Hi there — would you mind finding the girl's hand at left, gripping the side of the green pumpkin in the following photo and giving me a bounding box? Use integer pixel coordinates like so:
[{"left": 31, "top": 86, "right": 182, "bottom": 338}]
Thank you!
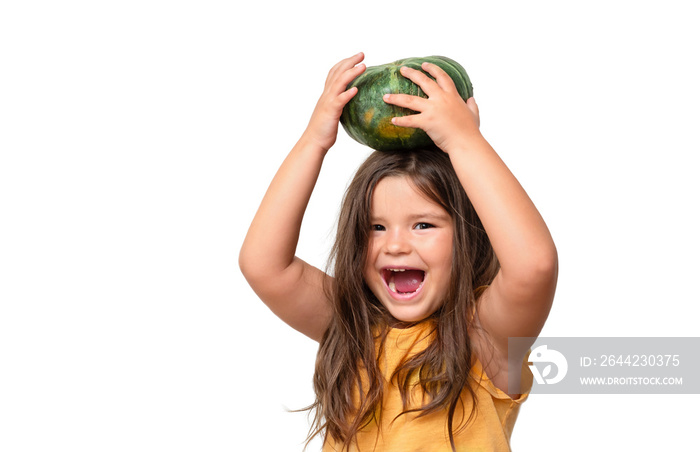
[{"left": 303, "top": 52, "right": 366, "bottom": 152}]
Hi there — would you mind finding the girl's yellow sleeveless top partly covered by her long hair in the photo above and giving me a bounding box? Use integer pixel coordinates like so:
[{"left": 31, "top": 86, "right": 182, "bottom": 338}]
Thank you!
[{"left": 323, "top": 322, "right": 532, "bottom": 452}]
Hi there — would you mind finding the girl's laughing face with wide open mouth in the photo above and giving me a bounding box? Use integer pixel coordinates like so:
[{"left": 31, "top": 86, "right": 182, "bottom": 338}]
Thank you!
[{"left": 363, "top": 176, "right": 454, "bottom": 322}]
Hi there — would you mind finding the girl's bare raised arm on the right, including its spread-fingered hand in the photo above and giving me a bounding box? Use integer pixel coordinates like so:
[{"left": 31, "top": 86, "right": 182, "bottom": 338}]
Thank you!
[{"left": 385, "top": 63, "right": 558, "bottom": 389}]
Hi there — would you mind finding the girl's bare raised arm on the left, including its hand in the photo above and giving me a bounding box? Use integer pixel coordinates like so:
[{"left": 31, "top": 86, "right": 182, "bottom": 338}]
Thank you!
[{"left": 238, "top": 53, "right": 365, "bottom": 340}]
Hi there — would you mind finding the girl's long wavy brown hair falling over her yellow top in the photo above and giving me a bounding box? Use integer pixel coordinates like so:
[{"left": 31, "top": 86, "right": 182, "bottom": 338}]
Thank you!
[{"left": 307, "top": 149, "right": 499, "bottom": 450}]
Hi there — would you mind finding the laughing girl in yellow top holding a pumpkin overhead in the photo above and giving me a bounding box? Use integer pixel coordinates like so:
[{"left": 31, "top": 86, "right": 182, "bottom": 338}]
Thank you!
[{"left": 239, "top": 53, "right": 557, "bottom": 451}]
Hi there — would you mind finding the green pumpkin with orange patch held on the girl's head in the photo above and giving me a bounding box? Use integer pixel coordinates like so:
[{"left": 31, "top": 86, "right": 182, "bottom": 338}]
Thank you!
[{"left": 340, "top": 56, "right": 473, "bottom": 151}]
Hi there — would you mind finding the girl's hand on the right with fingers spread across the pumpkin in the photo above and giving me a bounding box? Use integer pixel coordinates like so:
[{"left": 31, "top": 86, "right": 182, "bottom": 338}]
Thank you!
[{"left": 384, "top": 63, "right": 481, "bottom": 154}]
